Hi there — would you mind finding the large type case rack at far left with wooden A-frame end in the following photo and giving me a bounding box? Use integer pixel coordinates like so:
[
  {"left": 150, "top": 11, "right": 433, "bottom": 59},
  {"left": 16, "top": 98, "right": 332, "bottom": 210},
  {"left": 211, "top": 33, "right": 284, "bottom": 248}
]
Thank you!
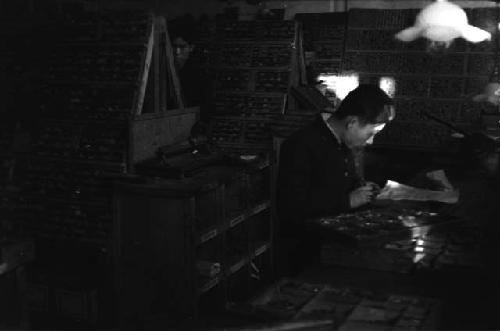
[{"left": 0, "top": 8, "right": 198, "bottom": 327}]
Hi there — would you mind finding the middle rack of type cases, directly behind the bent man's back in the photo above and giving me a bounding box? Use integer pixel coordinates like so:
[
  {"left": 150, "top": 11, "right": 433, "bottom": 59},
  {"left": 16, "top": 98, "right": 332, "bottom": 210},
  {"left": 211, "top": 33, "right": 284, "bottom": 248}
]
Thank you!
[{"left": 211, "top": 21, "right": 305, "bottom": 153}]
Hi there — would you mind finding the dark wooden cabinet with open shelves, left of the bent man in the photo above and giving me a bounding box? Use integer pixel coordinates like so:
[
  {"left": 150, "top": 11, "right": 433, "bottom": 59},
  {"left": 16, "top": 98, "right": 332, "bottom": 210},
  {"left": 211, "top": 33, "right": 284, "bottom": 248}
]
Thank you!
[{"left": 114, "top": 162, "right": 273, "bottom": 325}]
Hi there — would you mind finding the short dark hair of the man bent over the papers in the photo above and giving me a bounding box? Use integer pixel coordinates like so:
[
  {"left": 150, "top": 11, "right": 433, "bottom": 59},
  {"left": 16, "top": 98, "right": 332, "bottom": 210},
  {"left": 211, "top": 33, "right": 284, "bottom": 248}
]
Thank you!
[{"left": 333, "top": 84, "right": 394, "bottom": 124}]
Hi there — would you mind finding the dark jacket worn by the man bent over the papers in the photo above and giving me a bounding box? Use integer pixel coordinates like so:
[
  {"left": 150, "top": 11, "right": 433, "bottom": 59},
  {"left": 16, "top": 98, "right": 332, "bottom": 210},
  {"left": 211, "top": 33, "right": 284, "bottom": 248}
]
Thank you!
[{"left": 277, "top": 116, "right": 360, "bottom": 236}]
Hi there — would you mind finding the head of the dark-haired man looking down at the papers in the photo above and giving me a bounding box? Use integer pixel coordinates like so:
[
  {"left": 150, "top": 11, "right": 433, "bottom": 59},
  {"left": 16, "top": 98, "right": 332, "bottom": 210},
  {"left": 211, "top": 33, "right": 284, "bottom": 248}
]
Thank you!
[{"left": 332, "top": 84, "right": 395, "bottom": 148}]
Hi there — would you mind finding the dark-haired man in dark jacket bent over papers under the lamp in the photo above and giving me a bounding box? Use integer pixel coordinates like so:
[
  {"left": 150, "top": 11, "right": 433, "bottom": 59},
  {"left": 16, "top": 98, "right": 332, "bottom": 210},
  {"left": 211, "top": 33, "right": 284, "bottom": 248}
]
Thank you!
[{"left": 277, "top": 85, "right": 394, "bottom": 274}]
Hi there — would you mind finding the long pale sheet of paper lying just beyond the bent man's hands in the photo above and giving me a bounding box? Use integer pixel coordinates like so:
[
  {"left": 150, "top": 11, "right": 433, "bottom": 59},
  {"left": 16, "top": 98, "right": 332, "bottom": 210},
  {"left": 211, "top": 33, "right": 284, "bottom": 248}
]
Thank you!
[{"left": 377, "top": 180, "right": 459, "bottom": 203}]
